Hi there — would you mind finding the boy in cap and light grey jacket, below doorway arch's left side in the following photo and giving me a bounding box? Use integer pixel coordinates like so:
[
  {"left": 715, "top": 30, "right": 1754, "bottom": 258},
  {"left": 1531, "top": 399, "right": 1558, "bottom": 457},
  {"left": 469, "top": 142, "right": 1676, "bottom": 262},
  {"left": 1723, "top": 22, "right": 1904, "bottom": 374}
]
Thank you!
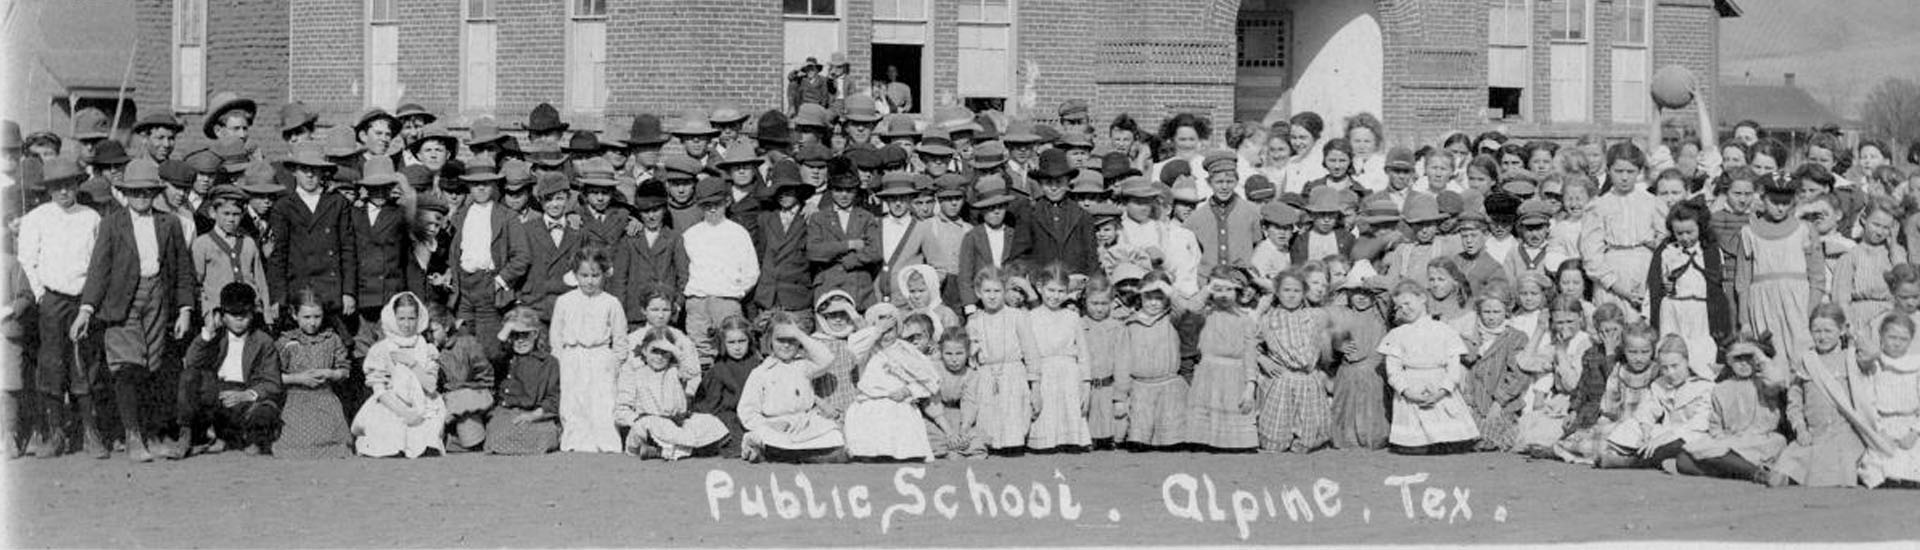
[{"left": 1187, "top": 150, "right": 1260, "bottom": 273}]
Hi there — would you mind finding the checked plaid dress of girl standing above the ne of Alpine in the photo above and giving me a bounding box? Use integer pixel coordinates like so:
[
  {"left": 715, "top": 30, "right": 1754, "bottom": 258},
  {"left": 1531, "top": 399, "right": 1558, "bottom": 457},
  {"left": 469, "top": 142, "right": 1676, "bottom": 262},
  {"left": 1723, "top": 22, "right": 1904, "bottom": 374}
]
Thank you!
[{"left": 1260, "top": 308, "right": 1332, "bottom": 452}]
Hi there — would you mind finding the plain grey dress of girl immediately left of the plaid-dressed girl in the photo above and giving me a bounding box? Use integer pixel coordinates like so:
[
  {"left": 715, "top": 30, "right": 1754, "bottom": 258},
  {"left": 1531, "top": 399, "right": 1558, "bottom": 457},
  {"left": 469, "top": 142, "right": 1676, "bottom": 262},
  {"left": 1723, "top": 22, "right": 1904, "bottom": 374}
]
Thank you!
[{"left": 1187, "top": 312, "right": 1260, "bottom": 448}]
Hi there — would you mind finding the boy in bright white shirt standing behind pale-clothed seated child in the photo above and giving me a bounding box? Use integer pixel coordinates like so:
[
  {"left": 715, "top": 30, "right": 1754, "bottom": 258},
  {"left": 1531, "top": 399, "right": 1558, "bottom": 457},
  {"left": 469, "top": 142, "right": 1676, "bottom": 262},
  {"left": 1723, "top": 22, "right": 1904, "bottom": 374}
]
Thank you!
[{"left": 682, "top": 177, "right": 760, "bottom": 363}]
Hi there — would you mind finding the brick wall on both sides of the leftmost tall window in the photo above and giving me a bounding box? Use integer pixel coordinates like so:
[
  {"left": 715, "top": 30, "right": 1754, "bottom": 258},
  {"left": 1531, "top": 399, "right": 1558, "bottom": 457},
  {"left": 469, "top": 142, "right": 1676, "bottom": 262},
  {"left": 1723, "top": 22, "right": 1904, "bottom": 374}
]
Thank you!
[{"left": 132, "top": 0, "right": 298, "bottom": 158}]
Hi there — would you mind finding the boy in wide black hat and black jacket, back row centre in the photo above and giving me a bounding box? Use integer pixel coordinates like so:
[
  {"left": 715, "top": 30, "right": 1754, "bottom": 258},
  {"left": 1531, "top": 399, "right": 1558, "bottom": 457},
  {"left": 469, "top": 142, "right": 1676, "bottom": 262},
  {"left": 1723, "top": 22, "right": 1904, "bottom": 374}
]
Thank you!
[{"left": 1014, "top": 150, "right": 1098, "bottom": 275}]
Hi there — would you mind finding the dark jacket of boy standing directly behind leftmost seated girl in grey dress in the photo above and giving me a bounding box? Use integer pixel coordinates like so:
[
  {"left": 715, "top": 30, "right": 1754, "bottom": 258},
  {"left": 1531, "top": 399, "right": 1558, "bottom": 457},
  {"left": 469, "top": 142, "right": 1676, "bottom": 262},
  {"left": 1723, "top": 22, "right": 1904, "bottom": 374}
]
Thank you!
[{"left": 267, "top": 190, "right": 359, "bottom": 304}]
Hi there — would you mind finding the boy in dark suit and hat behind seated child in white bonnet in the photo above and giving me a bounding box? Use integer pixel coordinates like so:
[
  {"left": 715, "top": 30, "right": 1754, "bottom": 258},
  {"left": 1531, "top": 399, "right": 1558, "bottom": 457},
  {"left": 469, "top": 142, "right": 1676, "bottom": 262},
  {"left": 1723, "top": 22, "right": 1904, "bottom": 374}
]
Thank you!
[{"left": 349, "top": 158, "right": 424, "bottom": 354}]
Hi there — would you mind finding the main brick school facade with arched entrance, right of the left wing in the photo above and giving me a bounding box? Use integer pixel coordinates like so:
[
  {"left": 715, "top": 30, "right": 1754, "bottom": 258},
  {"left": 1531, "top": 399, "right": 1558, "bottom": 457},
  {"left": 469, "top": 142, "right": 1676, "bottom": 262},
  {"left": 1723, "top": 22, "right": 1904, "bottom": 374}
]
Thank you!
[{"left": 266, "top": 0, "right": 1738, "bottom": 142}]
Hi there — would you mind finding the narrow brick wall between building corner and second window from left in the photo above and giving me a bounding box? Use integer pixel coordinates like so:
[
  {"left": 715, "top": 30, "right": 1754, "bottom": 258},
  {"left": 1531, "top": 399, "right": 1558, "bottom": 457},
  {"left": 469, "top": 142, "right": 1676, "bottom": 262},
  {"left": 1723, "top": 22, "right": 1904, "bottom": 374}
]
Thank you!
[{"left": 286, "top": 0, "right": 367, "bottom": 125}]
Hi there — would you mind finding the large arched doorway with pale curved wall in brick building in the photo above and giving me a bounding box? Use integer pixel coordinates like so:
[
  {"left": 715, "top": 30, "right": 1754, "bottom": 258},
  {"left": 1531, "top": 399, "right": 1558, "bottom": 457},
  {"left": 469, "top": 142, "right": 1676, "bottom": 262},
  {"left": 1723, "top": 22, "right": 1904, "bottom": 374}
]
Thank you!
[{"left": 1233, "top": 0, "right": 1386, "bottom": 129}]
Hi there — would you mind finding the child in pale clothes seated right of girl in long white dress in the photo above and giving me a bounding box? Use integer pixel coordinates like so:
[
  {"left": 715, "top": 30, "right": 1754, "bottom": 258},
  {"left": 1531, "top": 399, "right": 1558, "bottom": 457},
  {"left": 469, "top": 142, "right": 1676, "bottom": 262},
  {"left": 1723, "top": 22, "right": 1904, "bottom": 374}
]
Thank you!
[{"left": 612, "top": 327, "right": 728, "bottom": 460}]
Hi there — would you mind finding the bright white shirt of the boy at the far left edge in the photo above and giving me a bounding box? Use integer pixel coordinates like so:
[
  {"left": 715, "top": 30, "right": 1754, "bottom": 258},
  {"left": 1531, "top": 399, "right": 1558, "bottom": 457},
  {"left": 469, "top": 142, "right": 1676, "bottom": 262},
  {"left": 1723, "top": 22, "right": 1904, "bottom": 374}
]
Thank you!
[{"left": 19, "top": 202, "right": 100, "bottom": 298}]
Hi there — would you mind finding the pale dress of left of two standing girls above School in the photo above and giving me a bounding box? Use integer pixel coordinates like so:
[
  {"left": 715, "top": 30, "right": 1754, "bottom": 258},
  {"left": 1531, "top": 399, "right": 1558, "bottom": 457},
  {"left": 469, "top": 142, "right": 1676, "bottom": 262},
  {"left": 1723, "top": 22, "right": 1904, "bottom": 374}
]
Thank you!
[{"left": 966, "top": 308, "right": 1033, "bottom": 448}]
